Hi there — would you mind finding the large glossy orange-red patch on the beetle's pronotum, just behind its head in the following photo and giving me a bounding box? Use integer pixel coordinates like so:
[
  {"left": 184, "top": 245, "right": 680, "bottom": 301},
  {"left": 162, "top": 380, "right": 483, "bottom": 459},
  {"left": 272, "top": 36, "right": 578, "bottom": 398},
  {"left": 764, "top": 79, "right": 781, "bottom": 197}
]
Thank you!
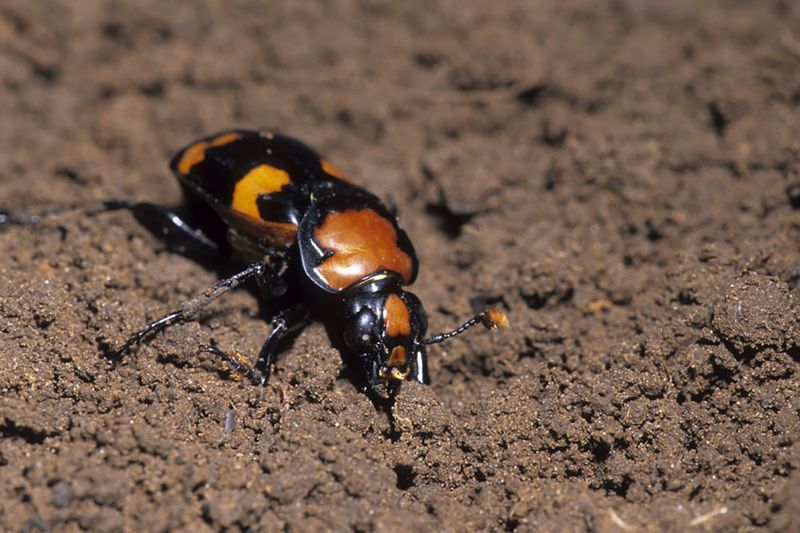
[{"left": 314, "top": 208, "right": 413, "bottom": 289}]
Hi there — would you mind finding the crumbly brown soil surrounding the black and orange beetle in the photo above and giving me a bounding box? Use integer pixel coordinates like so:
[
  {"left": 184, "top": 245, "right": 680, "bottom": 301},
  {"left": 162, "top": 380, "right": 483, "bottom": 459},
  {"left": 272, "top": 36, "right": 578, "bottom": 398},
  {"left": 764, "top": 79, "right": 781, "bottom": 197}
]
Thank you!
[{"left": 0, "top": 0, "right": 800, "bottom": 532}]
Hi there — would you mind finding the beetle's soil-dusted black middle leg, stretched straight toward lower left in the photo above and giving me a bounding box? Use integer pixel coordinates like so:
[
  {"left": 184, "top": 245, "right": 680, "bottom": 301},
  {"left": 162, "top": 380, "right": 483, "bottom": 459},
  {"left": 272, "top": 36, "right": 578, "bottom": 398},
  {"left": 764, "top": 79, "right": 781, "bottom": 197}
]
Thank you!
[{"left": 111, "top": 262, "right": 268, "bottom": 359}]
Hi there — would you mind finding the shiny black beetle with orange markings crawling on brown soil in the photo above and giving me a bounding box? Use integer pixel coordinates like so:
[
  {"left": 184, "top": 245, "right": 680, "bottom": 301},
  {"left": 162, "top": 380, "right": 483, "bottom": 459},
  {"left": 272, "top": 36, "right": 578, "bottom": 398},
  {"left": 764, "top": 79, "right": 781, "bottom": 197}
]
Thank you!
[{"left": 0, "top": 129, "right": 508, "bottom": 398}]
